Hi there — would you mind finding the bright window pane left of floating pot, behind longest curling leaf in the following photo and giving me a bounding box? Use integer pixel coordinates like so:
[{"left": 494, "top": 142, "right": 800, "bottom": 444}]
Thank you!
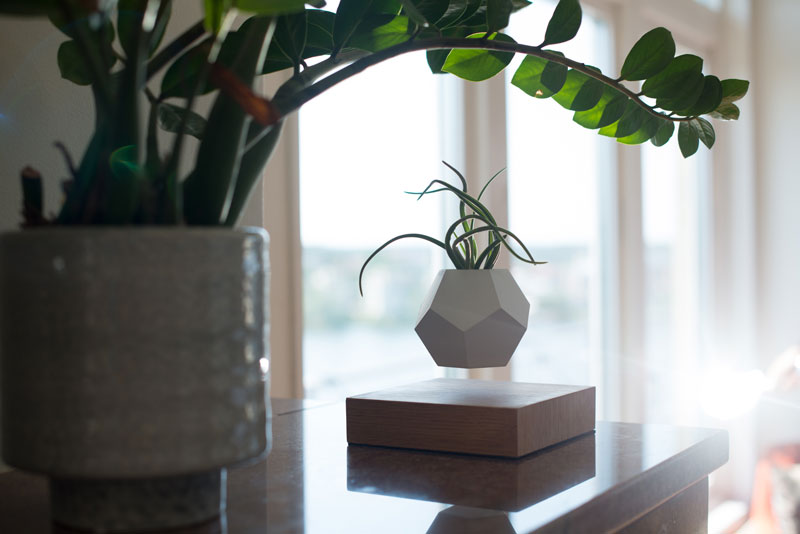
[{"left": 300, "top": 54, "right": 441, "bottom": 398}]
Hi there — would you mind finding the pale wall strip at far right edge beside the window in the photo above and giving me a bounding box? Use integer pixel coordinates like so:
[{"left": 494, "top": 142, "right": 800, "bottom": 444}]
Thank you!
[{"left": 749, "top": 0, "right": 800, "bottom": 366}]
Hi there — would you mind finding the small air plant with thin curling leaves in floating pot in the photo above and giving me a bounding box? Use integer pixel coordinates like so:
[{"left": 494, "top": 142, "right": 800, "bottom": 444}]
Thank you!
[{"left": 358, "top": 161, "right": 547, "bottom": 296}]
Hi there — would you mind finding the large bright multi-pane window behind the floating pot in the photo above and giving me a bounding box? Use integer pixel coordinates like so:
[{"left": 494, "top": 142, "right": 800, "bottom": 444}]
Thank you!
[{"left": 273, "top": 0, "right": 746, "bottom": 478}]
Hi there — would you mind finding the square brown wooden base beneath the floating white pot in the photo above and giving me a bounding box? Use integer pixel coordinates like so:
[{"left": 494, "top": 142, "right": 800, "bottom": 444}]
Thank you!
[{"left": 347, "top": 378, "right": 595, "bottom": 458}]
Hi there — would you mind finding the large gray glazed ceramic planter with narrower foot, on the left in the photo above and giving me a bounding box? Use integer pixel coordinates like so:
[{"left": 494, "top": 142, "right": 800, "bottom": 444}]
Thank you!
[{"left": 0, "top": 228, "right": 268, "bottom": 531}]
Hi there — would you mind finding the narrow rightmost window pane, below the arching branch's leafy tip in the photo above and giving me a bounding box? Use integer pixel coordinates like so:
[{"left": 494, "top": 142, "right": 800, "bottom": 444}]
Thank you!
[{"left": 642, "top": 141, "right": 709, "bottom": 424}]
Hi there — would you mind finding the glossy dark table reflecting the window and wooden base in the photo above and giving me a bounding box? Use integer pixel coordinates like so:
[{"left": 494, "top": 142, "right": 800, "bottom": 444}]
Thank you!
[{"left": 0, "top": 400, "right": 728, "bottom": 534}]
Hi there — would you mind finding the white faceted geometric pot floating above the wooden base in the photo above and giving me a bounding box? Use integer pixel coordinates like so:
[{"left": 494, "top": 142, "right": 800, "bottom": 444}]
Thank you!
[{"left": 415, "top": 269, "right": 530, "bottom": 369}]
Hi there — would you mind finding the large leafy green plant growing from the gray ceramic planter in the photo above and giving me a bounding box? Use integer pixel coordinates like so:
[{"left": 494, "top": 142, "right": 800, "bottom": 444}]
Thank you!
[{"left": 0, "top": 0, "right": 748, "bottom": 228}]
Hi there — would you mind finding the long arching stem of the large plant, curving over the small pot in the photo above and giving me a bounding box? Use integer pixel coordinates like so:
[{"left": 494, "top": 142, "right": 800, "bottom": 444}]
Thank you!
[{"left": 273, "top": 37, "right": 694, "bottom": 122}]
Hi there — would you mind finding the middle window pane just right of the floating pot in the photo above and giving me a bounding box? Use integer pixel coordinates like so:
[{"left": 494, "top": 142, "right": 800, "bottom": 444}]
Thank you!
[{"left": 507, "top": 1, "right": 610, "bottom": 390}]
